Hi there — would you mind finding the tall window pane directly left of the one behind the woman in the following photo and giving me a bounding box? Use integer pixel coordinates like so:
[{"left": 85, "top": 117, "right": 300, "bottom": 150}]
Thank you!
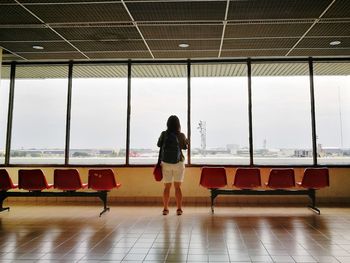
[{"left": 69, "top": 65, "right": 127, "bottom": 164}]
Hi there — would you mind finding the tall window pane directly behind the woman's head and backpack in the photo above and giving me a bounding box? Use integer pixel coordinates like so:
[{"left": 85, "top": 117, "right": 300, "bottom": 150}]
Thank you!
[{"left": 130, "top": 65, "right": 187, "bottom": 164}]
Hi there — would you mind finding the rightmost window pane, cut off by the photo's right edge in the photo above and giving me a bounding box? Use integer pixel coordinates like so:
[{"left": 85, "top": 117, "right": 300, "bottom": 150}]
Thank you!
[{"left": 314, "top": 63, "right": 350, "bottom": 164}]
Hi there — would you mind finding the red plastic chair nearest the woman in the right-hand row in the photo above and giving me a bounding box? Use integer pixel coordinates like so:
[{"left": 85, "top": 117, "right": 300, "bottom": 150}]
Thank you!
[{"left": 199, "top": 167, "right": 227, "bottom": 189}]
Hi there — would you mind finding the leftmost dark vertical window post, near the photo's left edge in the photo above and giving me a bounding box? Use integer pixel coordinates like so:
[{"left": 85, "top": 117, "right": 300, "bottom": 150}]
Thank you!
[{"left": 5, "top": 62, "right": 16, "bottom": 166}]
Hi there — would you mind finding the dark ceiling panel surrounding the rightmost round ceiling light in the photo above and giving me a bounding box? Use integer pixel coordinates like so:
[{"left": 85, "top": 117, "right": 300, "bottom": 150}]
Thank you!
[{"left": 296, "top": 36, "right": 350, "bottom": 49}]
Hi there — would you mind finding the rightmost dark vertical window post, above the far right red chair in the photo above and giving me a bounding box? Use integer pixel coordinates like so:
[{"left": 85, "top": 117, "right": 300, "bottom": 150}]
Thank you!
[{"left": 309, "top": 57, "right": 317, "bottom": 166}]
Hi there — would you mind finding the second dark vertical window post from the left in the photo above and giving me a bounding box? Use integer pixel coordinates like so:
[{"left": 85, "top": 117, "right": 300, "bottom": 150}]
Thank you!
[{"left": 64, "top": 62, "right": 73, "bottom": 165}]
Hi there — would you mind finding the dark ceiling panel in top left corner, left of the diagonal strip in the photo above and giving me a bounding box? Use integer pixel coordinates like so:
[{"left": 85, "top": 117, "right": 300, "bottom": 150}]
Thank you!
[{"left": 0, "top": 5, "right": 41, "bottom": 25}]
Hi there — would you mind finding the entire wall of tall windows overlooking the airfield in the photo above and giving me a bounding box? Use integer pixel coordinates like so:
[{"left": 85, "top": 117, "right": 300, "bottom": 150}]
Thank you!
[{"left": 0, "top": 60, "right": 350, "bottom": 166}]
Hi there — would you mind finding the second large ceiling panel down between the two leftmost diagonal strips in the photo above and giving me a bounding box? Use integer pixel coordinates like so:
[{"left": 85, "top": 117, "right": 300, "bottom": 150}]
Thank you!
[{"left": 54, "top": 26, "right": 141, "bottom": 40}]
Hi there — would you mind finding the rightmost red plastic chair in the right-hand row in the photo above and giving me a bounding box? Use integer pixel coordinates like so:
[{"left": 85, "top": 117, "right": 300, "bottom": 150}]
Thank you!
[{"left": 297, "top": 168, "right": 329, "bottom": 189}]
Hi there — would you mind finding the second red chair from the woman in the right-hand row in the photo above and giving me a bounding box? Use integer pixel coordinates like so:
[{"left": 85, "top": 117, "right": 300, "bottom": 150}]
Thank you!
[{"left": 233, "top": 168, "right": 261, "bottom": 189}]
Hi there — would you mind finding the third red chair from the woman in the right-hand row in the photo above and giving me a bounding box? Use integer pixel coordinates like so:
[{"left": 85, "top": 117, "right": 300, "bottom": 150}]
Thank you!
[{"left": 266, "top": 169, "right": 295, "bottom": 189}]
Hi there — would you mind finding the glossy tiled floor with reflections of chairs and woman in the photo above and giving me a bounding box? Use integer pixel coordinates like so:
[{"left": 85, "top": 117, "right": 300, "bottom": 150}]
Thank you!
[{"left": 0, "top": 205, "right": 350, "bottom": 263}]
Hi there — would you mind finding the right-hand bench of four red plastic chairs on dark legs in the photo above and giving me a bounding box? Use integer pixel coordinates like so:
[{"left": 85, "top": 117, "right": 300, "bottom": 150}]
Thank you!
[{"left": 200, "top": 167, "right": 329, "bottom": 214}]
